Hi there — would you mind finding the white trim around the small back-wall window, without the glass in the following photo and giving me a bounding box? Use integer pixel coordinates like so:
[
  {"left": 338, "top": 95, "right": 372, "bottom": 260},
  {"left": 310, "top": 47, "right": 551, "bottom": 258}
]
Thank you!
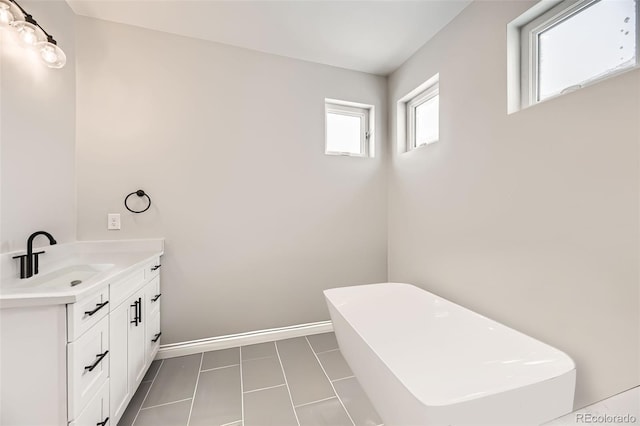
[{"left": 324, "top": 99, "right": 374, "bottom": 157}]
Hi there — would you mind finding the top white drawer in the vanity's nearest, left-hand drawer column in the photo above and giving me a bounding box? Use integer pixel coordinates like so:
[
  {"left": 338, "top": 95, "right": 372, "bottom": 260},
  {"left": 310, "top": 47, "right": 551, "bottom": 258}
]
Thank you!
[{"left": 67, "top": 287, "right": 109, "bottom": 342}]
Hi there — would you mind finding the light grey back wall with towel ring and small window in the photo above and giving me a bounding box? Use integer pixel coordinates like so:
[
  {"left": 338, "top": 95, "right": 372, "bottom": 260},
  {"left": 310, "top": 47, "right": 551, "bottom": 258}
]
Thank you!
[{"left": 77, "top": 17, "right": 387, "bottom": 343}]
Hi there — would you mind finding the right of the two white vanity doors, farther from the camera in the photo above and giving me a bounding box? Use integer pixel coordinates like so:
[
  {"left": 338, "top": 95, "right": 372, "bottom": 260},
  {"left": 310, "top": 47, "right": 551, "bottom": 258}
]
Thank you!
[{"left": 127, "top": 288, "right": 147, "bottom": 390}]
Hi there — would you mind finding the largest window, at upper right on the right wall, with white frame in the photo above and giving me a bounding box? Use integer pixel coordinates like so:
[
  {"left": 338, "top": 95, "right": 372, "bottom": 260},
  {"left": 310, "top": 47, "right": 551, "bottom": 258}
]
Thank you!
[{"left": 520, "top": 0, "right": 640, "bottom": 107}]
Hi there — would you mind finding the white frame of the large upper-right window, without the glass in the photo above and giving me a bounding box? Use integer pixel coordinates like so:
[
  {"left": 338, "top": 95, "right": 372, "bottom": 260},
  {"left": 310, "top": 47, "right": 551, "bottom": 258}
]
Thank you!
[{"left": 519, "top": 0, "right": 640, "bottom": 108}]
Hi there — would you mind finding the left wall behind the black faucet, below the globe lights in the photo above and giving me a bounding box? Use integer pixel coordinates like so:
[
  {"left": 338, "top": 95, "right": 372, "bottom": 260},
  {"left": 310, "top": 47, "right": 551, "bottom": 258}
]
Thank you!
[{"left": 0, "top": 1, "right": 76, "bottom": 253}]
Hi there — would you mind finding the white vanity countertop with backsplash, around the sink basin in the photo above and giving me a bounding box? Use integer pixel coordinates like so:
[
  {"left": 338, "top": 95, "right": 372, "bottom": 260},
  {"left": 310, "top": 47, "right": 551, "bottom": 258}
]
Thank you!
[{"left": 0, "top": 239, "right": 164, "bottom": 308}]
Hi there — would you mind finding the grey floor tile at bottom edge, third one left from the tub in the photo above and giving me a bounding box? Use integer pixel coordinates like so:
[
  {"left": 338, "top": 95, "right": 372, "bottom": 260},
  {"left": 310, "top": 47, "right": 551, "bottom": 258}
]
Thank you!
[{"left": 244, "top": 386, "right": 298, "bottom": 426}]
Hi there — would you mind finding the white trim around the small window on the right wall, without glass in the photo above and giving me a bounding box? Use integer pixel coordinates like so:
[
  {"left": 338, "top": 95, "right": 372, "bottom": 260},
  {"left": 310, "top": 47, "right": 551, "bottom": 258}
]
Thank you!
[{"left": 396, "top": 73, "right": 440, "bottom": 153}]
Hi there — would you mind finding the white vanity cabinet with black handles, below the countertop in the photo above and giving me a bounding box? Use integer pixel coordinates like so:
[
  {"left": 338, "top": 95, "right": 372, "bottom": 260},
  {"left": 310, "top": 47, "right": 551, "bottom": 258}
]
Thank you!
[{"left": 0, "top": 250, "right": 160, "bottom": 426}]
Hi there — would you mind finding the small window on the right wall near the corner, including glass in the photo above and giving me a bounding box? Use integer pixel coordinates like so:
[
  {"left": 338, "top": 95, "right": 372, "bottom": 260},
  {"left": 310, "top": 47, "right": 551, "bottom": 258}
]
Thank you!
[{"left": 397, "top": 74, "right": 440, "bottom": 152}]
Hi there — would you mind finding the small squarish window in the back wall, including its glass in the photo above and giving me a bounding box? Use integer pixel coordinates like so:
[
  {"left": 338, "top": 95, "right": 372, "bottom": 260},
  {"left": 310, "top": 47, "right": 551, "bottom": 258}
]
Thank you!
[{"left": 325, "top": 99, "right": 373, "bottom": 157}]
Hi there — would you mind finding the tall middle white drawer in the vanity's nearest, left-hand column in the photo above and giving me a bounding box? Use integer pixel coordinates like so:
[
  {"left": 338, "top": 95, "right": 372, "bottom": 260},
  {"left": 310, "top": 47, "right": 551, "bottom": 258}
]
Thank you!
[{"left": 67, "top": 317, "right": 109, "bottom": 420}]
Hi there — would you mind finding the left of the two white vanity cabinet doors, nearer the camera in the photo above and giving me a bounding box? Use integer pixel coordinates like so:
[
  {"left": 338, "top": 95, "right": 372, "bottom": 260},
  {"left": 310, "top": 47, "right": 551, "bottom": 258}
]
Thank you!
[{"left": 109, "top": 301, "right": 135, "bottom": 421}]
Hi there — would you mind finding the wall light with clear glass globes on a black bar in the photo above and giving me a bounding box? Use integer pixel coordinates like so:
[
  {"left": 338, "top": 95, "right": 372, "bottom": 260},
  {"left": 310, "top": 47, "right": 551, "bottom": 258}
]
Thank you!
[{"left": 0, "top": 0, "right": 67, "bottom": 68}]
